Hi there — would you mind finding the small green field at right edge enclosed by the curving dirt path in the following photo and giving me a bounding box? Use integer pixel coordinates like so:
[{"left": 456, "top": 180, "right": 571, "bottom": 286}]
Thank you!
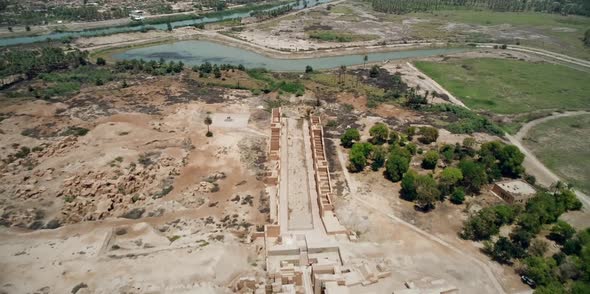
[{"left": 525, "top": 114, "right": 590, "bottom": 193}]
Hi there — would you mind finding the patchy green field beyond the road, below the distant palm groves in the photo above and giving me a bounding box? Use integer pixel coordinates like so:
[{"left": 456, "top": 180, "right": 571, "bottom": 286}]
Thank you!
[{"left": 381, "top": 9, "right": 590, "bottom": 60}]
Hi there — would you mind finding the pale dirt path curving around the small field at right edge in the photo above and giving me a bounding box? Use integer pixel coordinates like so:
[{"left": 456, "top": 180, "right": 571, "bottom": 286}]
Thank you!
[{"left": 506, "top": 111, "right": 590, "bottom": 209}]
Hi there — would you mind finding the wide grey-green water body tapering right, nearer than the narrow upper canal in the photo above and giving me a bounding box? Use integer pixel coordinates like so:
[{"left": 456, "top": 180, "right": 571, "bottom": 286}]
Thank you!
[{"left": 113, "top": 40, "right": 470, "bottom": 71}]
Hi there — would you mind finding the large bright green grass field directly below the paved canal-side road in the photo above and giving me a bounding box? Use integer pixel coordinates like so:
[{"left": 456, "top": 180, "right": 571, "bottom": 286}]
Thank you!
[{"left": 415, "top": 58, "right": 590, "bottom": 115}]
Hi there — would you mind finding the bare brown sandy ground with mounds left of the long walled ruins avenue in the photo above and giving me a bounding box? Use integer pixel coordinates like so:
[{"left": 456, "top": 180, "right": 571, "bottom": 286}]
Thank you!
[{"left": 0, "top": 72, "right": 269, "bottom": 293}]
